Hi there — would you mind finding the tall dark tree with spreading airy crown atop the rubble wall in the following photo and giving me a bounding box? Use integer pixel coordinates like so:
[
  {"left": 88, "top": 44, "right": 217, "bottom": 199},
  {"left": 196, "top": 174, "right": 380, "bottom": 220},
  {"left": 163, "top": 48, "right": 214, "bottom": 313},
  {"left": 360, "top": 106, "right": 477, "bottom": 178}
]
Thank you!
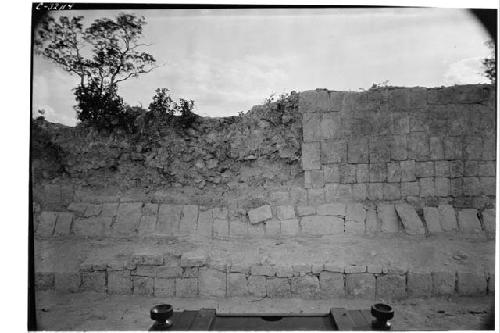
[{"left": 35, "top": 14, "right": 157, "bottom": 127}]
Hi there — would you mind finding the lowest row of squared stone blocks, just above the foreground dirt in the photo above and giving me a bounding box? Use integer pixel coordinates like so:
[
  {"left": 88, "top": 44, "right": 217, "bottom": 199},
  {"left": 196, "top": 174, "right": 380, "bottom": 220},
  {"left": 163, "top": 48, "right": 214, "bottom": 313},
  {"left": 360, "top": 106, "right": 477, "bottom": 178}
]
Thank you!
[{"left": 35, "top": 251, "right": 495, "bottom": 299}]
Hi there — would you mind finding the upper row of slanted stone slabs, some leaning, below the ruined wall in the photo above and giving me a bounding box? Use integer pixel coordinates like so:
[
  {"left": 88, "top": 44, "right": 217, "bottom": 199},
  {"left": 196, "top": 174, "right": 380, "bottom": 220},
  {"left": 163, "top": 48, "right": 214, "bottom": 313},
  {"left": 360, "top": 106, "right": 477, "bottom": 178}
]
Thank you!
[{"left": 35, "top": 196, "right": 495, "bottom": 239}]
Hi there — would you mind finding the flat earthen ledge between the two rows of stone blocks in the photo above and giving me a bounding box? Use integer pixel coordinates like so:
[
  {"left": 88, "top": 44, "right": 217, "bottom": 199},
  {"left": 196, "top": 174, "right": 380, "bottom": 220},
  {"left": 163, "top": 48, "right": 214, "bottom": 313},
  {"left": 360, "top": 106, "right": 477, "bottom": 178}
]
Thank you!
[{"left": 35, "top": 234, "right": 495, "bottom": 272}]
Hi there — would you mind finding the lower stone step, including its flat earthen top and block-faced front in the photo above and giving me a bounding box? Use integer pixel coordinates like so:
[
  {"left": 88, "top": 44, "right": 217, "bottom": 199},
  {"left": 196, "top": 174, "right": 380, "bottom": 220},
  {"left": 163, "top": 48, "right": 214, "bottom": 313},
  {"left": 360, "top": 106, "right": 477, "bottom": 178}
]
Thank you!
[{"left": 35, "top": 235, "right": 495, "bottom": 299}]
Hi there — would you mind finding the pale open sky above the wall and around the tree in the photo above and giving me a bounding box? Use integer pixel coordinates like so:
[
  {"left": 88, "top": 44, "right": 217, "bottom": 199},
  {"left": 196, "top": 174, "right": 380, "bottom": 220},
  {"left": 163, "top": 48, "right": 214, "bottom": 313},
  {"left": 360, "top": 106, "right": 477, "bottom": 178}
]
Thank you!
[{"left": 33, "top": 8, "right": 490, "bottom": 126}]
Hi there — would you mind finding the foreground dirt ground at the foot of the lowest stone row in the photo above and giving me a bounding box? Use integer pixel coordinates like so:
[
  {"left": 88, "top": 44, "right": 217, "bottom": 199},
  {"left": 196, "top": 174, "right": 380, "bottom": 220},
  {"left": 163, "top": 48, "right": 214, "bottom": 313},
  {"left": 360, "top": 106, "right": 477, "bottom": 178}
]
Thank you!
[{"left": 36, "top": 291, "right": 494, "bottom": 331}]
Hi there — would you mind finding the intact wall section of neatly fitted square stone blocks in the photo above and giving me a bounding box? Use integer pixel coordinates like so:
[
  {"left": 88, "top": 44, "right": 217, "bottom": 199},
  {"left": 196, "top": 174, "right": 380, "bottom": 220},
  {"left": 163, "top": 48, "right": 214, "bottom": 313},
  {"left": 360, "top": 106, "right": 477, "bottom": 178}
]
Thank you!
[{"left": 299, "top": 85, "right": 496, "bottom": 209}]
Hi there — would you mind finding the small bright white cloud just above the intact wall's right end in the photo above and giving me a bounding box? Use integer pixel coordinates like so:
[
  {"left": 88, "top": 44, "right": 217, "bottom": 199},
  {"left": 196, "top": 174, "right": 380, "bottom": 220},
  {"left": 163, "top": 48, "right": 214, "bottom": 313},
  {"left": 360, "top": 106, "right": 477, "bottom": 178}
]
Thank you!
[{"left": 444, "top": 57, "right": 488, "bottom": 85}]
